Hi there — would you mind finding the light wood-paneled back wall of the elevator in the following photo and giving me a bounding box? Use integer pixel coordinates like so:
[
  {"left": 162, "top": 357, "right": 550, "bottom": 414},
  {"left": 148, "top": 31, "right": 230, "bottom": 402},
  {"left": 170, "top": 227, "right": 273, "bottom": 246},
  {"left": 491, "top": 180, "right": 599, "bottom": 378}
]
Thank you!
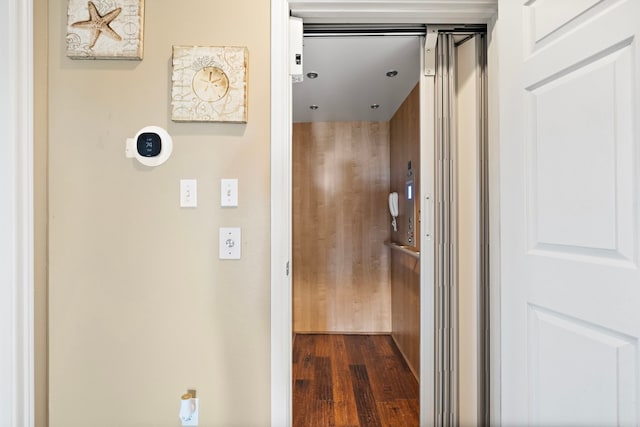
[{"left": 292, "top": 122, "right": 391, "bottom": 332}]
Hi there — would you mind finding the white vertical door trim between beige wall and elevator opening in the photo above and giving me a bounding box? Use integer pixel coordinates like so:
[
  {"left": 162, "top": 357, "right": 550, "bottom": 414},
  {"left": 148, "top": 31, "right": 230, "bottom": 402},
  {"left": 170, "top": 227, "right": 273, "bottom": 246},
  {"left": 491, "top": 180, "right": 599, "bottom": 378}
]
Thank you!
[{"left": 271, "top": 0, "right": 292, "bottom": 427}]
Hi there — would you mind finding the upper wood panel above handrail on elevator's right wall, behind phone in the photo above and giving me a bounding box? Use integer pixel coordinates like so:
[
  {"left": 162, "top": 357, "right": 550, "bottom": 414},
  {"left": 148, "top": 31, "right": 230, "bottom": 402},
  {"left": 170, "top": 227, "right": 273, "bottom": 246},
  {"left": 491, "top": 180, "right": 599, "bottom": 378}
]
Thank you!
[{"left": 389, "top": 85, "right": 420, "bottom": 247}]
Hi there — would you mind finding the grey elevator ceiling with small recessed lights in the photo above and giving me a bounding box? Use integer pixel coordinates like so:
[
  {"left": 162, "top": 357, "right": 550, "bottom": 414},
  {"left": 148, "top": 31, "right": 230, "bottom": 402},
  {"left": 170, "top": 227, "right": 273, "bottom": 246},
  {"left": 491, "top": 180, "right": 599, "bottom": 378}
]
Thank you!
[{"left": 293, "top": 36, "right": 420, "bottom": 122}]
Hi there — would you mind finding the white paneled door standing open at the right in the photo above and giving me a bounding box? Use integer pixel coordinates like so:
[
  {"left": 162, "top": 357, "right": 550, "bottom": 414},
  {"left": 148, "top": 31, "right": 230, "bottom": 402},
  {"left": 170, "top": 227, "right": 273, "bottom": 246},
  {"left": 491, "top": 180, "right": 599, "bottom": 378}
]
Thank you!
[{"left": 499, "top": 0, "right": 640, "bottom": 426}]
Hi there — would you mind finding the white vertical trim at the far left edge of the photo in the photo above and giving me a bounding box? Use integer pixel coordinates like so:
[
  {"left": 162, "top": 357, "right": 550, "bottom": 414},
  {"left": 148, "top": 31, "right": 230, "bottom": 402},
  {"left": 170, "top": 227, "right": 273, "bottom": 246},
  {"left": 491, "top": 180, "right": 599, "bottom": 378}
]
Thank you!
[{"left": 0, "top": 0, "right": 34, "bottom": 427}]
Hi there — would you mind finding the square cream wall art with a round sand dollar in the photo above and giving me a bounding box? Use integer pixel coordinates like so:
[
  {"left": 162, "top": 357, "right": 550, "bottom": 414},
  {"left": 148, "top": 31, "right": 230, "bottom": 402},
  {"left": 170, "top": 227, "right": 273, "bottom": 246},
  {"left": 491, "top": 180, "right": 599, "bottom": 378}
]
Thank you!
[{"left": 171, "top": 46, "right": 248, "bottom": 123}]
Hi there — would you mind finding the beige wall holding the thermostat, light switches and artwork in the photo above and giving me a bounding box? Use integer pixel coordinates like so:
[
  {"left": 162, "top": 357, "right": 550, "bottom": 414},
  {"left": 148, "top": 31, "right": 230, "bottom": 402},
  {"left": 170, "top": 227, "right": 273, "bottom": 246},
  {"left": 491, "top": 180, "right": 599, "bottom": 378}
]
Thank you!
[{"left": 48, "top": 0, "right": 270, "bottom": 427}]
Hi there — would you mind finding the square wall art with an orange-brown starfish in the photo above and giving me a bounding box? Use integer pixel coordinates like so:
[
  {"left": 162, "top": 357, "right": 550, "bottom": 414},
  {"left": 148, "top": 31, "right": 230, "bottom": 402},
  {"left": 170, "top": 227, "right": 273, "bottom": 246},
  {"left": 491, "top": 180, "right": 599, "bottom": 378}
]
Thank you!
[{"left": 67, "top": 0, "right": 144, "bottom": 59}]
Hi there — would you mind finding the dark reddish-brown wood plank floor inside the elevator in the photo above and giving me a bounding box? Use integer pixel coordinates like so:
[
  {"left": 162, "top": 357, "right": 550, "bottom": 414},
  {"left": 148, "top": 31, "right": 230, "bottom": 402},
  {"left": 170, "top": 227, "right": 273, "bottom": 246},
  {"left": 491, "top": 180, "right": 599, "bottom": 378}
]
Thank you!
[{"left": 293, "top": 335, "right": 420, "bottom": 427}]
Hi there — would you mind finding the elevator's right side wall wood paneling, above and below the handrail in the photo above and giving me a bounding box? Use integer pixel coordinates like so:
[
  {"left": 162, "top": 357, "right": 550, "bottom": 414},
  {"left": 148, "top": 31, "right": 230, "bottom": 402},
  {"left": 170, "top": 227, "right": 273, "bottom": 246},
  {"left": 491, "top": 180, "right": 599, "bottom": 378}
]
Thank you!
[{"left": 390, "top": 86, "right": 420, "bottom": 377}]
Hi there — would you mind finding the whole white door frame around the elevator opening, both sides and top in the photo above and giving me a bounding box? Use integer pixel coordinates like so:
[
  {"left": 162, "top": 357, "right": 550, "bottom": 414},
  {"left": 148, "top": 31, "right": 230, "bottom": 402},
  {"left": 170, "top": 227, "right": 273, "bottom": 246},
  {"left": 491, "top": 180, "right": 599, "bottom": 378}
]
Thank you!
[{"left": 270, "top": 0, "right": 500, "bottom": 426}]
